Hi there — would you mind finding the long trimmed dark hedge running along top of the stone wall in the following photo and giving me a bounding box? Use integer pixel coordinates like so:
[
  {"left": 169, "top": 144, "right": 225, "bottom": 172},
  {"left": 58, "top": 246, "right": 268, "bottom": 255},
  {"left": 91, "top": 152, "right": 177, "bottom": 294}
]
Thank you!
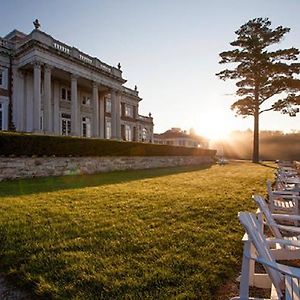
[{"left": 0, "top": 132, "right": 216, "bottom": 157}]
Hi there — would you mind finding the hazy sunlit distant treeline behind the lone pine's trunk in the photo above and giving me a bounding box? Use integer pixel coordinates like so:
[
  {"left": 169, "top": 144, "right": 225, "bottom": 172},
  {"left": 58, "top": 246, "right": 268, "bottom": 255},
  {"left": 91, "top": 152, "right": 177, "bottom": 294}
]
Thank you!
[{"left": 210, "top": 130, "right": 300, "bottom": 160}]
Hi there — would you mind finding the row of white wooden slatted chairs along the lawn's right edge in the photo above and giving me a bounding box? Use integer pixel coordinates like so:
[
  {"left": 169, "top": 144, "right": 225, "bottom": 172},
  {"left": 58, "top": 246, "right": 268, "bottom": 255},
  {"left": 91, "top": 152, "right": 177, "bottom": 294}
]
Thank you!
[{"left": 232, "top": 162, "right": 300, "bottom": 300}]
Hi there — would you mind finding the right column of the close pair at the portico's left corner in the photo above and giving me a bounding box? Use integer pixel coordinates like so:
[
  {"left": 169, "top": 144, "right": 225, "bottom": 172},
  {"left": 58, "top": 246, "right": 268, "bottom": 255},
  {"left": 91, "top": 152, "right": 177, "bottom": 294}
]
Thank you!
[{"left": 44, "top": 65, "right": 52, "bottom": 133}]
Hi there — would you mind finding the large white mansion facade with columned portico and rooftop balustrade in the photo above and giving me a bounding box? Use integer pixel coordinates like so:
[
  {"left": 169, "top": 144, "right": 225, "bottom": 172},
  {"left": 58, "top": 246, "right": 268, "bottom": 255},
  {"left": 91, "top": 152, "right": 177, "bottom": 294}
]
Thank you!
[{"left": 0, "top": 24, "right": 153, "bottom": 142}]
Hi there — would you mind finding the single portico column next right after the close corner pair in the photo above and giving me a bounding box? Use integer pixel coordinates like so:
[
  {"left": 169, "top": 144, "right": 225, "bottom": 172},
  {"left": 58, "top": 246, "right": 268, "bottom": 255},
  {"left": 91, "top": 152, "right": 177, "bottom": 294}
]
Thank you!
[{"left": 71, "top": 75, "right": 80, "bottom": 136}]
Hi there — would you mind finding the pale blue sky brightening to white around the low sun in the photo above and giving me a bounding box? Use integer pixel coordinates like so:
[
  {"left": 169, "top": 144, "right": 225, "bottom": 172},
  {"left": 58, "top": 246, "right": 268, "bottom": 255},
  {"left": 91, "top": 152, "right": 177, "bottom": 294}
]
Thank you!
[{"left": 0, "top": 0, "right": 300, "bottom": 138}]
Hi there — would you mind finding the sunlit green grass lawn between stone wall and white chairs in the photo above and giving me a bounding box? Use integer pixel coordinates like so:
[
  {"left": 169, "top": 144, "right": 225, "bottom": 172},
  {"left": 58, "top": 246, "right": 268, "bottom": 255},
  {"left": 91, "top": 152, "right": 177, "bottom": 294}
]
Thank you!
[{"left": 0, "top": 162, "right": 273, "bottom": 299}]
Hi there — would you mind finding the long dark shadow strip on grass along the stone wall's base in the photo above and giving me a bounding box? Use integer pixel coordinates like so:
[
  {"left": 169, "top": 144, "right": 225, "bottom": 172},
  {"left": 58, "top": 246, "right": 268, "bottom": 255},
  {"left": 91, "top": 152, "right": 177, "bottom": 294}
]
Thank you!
[{"left": 0, "top": 164, "right": 211, "bottom": 197}]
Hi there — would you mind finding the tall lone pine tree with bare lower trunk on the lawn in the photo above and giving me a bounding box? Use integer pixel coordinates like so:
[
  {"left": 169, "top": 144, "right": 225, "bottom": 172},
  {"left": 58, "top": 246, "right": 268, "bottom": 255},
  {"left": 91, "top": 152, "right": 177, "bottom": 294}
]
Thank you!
[{"left": 216, "top": 18, "right": 300, "bottom": 163}]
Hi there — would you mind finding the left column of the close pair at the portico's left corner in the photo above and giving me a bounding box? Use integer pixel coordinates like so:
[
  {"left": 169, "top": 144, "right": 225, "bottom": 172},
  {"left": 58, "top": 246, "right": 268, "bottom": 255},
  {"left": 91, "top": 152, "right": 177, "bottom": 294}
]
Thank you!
[{"left": 32, "top": 61, "right": 41, "bottom": 132}]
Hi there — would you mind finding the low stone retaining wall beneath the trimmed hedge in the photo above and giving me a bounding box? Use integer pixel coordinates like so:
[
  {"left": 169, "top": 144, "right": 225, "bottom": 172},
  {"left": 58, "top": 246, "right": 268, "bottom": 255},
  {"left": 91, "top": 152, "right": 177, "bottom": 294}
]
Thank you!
[{"left": 0, "top": 156, "right": 213, "bottom": 181}]
